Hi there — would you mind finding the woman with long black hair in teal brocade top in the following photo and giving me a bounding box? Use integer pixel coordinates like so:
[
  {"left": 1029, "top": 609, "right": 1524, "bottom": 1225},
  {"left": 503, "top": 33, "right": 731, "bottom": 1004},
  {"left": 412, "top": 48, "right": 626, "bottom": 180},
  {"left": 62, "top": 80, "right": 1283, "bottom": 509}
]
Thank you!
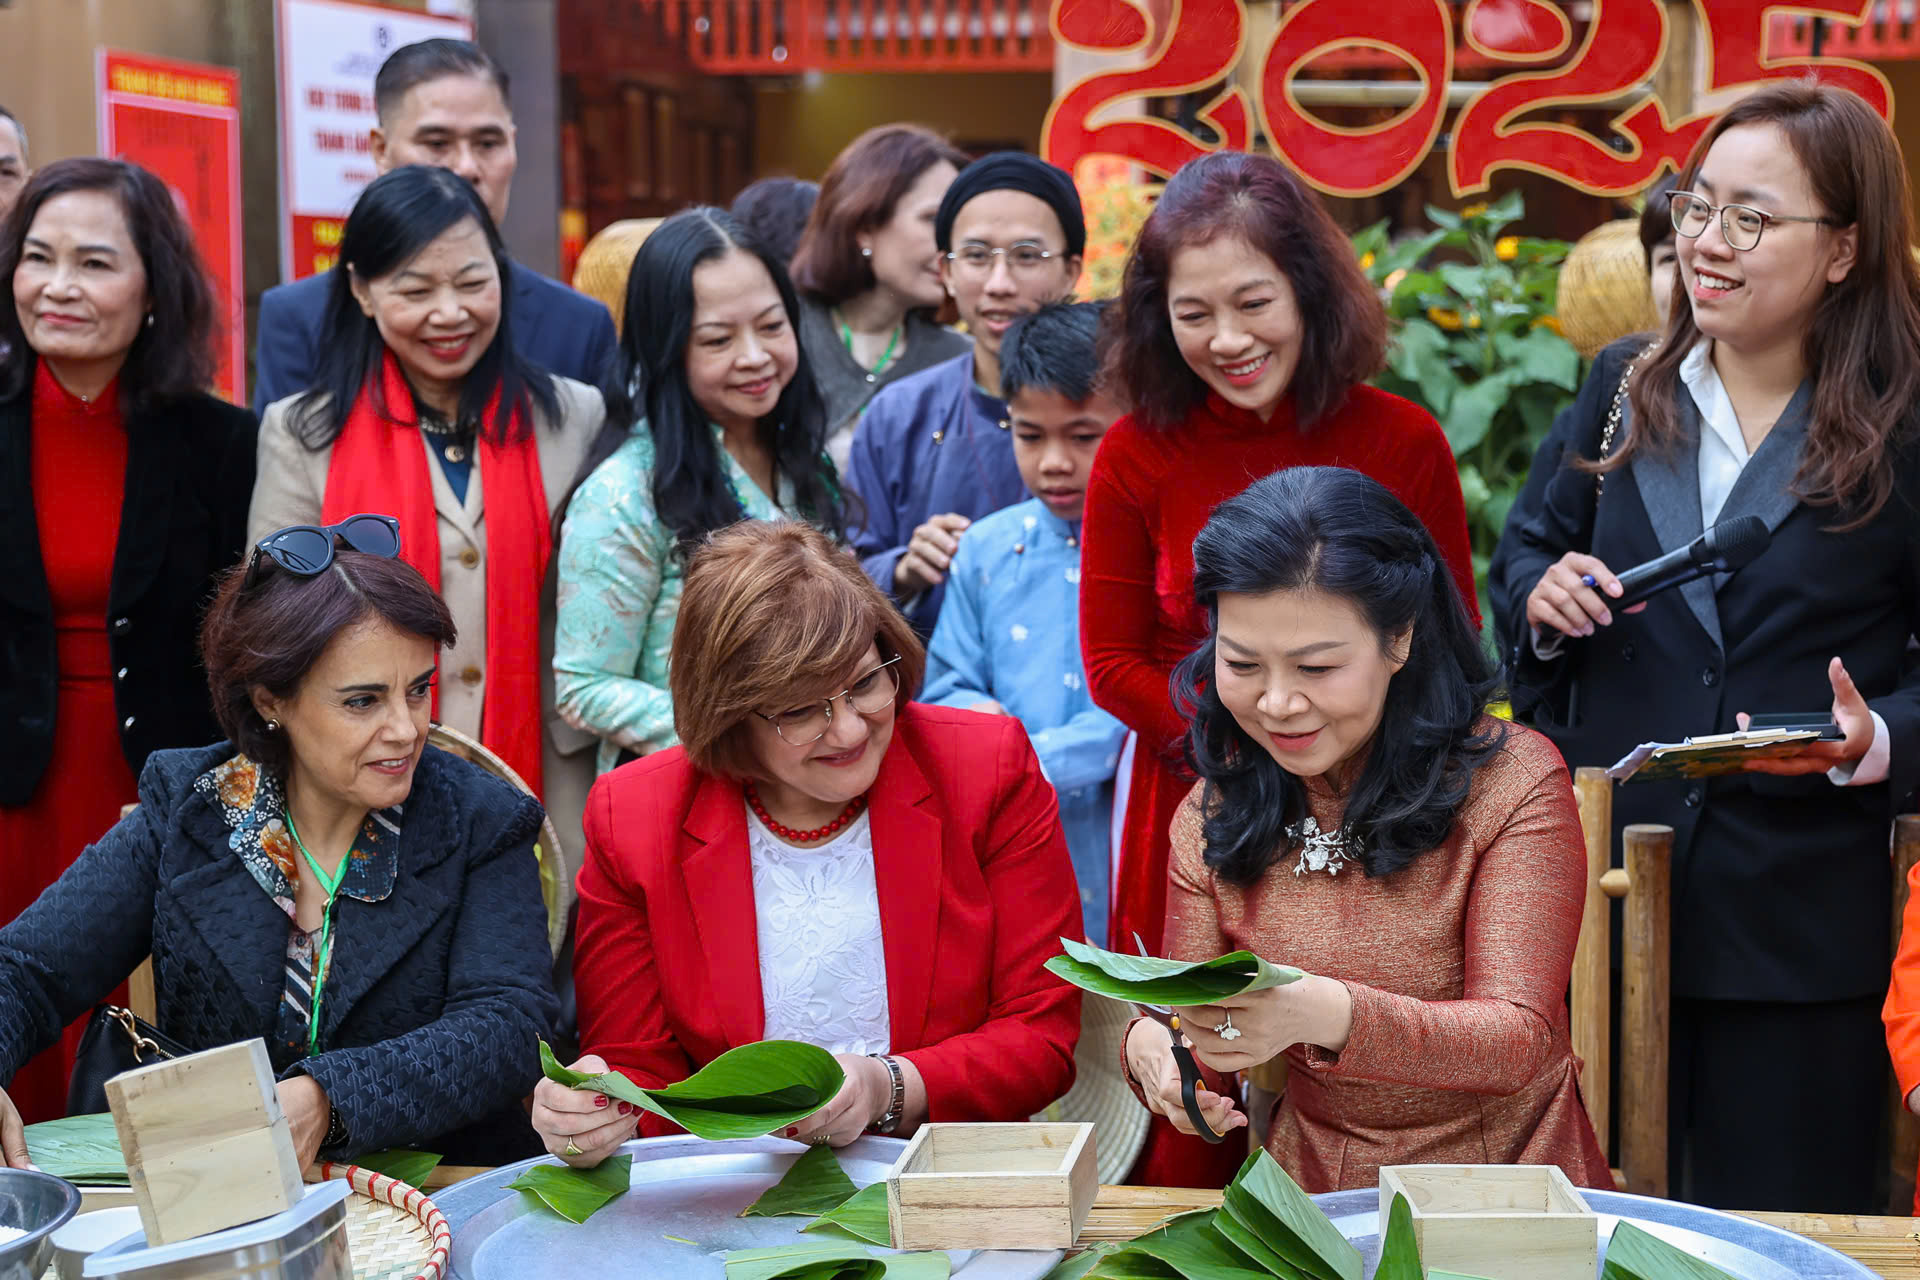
[{"left": 553, "top": 207, "right": 845, "bottom": 771}]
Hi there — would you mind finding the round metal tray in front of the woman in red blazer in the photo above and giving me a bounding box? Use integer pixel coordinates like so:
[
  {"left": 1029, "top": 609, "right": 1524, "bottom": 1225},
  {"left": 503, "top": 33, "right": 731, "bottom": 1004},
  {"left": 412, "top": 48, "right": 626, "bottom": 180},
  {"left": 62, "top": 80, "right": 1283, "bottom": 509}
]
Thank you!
[{"left": 434, "top": 1136, "right": 1060, "bottom": 1280}]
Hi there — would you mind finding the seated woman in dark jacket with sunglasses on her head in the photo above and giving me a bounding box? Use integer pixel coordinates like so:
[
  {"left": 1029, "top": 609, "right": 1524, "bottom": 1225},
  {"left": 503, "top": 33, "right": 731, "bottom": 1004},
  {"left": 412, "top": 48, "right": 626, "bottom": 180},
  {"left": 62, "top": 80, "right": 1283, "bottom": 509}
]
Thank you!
[{"left": 0, "top": 529, "right": 559, "bottom": 1167}]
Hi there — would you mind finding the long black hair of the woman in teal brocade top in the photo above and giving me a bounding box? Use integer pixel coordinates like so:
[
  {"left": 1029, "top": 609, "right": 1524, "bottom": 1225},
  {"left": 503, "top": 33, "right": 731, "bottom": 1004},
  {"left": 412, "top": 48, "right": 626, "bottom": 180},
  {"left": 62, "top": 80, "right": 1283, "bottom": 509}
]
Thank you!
[{"left": 589, "top": 205, "right": 847, "bottom": 557}]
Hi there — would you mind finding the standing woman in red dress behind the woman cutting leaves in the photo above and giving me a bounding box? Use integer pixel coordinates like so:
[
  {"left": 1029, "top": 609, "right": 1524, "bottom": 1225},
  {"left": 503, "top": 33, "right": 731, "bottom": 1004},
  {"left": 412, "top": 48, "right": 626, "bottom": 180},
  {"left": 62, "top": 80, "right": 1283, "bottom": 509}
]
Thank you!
[{"left": 1079, "top": 152, "right": 1475, "bottom": 1186}]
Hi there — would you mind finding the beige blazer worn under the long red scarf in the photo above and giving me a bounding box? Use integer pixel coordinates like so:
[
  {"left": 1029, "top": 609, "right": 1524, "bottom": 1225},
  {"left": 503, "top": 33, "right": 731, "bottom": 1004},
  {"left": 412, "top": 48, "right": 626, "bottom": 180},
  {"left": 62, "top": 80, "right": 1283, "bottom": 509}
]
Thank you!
[{"left": 248, "top": 378, "right": 607, "bottom": 885}]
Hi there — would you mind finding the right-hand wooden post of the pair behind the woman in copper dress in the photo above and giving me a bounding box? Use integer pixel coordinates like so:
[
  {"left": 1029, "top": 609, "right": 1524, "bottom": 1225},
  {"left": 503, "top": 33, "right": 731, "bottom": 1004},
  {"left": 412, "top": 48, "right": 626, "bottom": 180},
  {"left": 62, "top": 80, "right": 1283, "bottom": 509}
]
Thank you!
[{"left": 1620, "top": 823, "right": 1674, "bottom": 1197}]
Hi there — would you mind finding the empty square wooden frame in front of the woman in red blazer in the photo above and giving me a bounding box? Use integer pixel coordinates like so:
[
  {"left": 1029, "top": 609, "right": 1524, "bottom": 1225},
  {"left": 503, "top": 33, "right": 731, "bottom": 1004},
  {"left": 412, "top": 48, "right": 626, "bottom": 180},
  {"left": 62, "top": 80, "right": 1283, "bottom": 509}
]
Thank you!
[{"left": 887, "top": 1125, "right": 1100, "bottom": 1249}]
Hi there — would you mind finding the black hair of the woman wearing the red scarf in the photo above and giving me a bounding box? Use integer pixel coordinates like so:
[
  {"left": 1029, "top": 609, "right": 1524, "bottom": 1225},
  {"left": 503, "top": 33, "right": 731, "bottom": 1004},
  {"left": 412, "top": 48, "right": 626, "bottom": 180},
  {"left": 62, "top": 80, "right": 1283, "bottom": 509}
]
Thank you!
[{"left": 292, "top": 165, "right": 561, "bottom": 451}]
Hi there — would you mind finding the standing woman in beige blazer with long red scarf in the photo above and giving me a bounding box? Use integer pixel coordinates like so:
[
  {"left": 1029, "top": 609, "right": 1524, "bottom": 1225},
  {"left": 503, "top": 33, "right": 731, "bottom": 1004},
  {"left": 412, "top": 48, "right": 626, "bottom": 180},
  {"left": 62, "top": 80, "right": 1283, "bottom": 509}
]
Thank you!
[{"left": 248, "top": 165, "right": 605, "bottom": 871}]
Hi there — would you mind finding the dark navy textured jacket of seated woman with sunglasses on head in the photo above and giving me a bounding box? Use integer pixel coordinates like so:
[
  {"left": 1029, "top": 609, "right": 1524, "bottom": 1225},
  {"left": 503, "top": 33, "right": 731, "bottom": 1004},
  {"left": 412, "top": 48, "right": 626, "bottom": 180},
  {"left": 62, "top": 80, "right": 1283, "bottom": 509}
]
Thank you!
[{"left": 0, "top": 743, "right": 557, "bottom": 1163}]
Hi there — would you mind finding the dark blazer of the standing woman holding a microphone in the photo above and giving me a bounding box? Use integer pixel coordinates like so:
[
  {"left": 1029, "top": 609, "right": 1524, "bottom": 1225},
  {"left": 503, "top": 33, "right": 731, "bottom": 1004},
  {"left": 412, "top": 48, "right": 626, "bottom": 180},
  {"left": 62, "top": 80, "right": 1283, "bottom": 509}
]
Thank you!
[{"left": 1490, "top": 344, "right": 1920, "bottom": 1002}]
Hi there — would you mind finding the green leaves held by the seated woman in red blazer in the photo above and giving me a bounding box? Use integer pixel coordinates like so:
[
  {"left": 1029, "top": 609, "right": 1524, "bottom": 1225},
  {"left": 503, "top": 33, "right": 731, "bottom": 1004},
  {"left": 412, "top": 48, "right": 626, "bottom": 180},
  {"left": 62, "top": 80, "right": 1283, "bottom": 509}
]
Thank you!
[{"left": 540, "top": 1040, "right": 847, "bottom": 1142}]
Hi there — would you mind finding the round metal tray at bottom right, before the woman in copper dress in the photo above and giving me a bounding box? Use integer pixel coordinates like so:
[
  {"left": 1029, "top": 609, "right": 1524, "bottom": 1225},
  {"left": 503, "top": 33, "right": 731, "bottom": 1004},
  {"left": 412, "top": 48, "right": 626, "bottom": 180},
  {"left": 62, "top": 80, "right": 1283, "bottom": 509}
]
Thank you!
[{"left": 1313, "top": 1188, "right": 1878, "bottom": 1280}]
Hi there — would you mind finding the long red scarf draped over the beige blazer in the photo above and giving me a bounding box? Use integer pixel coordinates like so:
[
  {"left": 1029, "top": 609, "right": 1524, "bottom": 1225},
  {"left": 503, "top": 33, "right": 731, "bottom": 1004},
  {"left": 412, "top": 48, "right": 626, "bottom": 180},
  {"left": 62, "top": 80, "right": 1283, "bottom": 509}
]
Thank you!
[{"left": 321, "top": 351, "right": 553, "bottom": 794}]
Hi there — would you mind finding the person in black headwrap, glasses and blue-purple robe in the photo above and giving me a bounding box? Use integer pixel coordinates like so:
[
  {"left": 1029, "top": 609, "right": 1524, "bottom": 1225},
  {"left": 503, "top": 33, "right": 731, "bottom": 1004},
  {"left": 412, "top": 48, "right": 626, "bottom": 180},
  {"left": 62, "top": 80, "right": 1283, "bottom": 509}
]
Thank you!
[{"left": 847, "top": 152, "right": 1087, "bottom": 635}]
